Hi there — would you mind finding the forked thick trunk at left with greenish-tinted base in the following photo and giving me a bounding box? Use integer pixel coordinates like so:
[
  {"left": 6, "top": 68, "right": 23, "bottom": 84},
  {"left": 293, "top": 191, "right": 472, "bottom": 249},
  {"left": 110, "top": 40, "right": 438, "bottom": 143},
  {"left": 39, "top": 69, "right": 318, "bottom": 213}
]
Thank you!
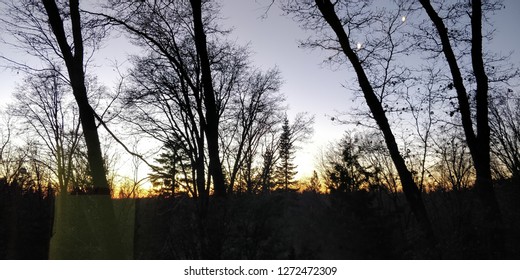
[{"left": 43, "top": 0, "right": 125, "bottom": 259}]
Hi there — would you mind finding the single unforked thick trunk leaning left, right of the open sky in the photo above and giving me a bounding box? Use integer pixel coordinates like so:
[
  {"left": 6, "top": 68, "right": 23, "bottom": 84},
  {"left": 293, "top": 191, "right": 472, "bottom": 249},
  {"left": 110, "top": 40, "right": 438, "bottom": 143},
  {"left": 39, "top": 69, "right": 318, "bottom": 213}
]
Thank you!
[{"left": 316, "top": 0, "right": 437, "bottom": 249}]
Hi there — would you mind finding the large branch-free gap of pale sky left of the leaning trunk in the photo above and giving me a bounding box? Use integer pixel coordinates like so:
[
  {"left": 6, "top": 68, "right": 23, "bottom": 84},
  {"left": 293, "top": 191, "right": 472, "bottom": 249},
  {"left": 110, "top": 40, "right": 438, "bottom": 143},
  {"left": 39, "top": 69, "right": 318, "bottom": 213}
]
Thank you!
[{"left": 217, "top": 0, "right": 351, "bottom": 177}]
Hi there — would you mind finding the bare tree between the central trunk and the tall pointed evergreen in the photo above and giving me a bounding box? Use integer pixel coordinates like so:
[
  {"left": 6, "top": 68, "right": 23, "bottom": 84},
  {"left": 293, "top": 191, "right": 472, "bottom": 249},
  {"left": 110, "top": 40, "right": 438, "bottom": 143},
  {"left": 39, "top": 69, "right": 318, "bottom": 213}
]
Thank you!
[{"left": 221, "top": 69, "right": 284, "bottom": 192}]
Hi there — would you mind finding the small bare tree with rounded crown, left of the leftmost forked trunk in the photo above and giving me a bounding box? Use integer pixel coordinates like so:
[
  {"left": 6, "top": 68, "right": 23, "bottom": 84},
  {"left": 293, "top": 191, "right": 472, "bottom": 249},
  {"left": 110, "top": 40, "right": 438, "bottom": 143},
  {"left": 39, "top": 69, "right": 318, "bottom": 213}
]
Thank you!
[{"left": 12, "top": 72, "right": 82, "bottom": 194}]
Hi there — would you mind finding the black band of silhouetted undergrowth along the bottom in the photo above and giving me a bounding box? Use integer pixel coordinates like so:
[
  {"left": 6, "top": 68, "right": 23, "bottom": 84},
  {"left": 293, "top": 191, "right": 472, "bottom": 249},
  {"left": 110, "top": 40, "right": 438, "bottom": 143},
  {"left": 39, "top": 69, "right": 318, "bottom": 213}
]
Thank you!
[{"left": 0, "top": 178, "right": 520, "bottom": 259}]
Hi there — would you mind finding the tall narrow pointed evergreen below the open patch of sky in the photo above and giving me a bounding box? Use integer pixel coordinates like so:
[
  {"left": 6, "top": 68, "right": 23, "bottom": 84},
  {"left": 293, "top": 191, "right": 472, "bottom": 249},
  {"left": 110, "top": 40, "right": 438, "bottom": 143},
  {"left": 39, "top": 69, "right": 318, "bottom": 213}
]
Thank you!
[{"left": 276, "top": 116, "right": 297, "bottom": 191}]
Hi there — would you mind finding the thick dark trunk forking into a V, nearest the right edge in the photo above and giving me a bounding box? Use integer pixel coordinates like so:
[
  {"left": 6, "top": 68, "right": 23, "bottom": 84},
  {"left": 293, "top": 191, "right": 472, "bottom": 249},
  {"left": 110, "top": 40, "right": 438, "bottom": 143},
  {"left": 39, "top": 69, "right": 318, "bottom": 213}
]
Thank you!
[{"left": 420, "top": 0, "right": 503, "bottom": 254}]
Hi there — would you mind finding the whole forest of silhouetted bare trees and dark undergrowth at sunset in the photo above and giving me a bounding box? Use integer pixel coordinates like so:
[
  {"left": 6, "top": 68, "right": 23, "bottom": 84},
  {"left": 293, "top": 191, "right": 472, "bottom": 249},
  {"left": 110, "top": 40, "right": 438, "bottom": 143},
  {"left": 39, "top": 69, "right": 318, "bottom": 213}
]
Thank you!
[{"left": 0, "top": 0, "right": 520, "bottom": 260}]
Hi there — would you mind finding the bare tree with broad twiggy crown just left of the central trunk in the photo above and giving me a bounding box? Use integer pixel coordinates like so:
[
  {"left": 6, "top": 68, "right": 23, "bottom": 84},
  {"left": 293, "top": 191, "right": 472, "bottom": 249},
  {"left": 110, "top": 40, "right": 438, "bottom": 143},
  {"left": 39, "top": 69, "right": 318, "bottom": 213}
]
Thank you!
[{"left": 121, "top": 50, "right": 209, "bottom": 200}]
